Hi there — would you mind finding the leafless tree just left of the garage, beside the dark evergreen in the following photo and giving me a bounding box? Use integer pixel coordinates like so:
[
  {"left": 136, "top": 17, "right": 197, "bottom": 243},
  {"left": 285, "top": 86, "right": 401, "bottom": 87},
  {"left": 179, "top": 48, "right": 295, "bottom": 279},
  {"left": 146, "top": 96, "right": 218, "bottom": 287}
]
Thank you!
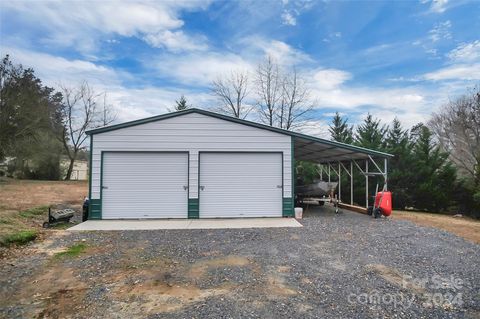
[{"left": 60, "top": 82, "right": 116, "bottom": 180}]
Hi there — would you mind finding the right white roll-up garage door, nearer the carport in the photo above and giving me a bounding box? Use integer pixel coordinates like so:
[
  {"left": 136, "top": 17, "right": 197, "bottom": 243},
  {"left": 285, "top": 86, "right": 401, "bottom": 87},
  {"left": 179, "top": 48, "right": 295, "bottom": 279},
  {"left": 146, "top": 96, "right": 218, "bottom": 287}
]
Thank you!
[{"left": 200, "top": 153, "right": 283, "bottom": 218}]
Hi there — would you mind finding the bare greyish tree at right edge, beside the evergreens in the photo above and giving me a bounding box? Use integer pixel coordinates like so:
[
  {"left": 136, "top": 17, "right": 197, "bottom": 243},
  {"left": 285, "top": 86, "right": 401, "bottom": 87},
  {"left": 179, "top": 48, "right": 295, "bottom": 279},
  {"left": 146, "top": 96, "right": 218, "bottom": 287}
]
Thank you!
[{"left": 429, "top": 87, "right": 480, "bottom": 185}]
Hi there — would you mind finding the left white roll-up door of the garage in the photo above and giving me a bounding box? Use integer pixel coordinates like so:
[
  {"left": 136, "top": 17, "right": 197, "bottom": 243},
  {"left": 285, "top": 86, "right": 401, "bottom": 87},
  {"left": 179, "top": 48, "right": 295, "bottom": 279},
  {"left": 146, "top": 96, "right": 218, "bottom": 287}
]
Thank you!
[{"left": 102, "top": 152, "right": 188, "bottom": 219}]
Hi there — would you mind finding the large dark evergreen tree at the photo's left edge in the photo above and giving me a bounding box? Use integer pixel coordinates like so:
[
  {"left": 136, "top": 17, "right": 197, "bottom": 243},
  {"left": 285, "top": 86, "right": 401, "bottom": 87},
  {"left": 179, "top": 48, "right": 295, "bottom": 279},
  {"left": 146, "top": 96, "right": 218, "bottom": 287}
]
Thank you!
[{"left": 0, "top": 55, "right": 63, "bottom": 179}]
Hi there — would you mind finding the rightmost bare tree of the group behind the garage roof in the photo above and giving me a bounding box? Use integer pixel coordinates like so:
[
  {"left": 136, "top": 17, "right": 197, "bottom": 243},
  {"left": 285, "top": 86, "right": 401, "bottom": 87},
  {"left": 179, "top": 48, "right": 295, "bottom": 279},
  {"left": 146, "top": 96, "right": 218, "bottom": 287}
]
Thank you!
[{"left": 277, "top": 68, "right": 313, "bottom": 130}]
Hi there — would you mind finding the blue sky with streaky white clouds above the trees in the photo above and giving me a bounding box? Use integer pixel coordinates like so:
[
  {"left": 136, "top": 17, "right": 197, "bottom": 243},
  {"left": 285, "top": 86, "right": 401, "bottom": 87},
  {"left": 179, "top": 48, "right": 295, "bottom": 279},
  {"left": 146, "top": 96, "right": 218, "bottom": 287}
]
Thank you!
[{"left": 0, "top": 0, "right": 480, "bottom": 136}]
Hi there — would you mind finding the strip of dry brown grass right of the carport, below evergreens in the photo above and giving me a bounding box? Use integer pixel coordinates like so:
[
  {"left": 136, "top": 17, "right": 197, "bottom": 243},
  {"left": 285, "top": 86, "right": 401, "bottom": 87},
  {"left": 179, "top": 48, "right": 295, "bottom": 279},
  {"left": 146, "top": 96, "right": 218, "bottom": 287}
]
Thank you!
[{"left": 392, "top": 211, "right": 480, "bottom": 244}]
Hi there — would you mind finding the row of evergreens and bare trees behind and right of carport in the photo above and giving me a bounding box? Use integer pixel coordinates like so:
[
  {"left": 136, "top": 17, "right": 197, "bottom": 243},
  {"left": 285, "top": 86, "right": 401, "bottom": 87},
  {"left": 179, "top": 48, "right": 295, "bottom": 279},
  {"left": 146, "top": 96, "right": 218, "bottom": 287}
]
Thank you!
[{"left": 328, "top": 88, "right": 480, "bottom": 217}]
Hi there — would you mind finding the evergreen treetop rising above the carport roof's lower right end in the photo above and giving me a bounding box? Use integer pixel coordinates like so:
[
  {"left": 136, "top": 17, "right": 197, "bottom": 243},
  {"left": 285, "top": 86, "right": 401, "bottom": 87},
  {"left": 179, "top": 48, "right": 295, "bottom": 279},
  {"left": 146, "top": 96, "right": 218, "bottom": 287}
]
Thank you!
[{"left": 355, "top": 114, "right": 387, "bottom": 151}]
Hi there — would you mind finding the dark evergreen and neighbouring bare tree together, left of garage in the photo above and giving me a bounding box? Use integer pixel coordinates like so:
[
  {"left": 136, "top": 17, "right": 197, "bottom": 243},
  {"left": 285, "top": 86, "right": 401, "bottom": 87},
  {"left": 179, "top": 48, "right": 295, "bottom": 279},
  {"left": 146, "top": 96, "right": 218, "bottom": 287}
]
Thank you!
[{"left": 0, "top": 55, "right": 115, "bottom": 180}]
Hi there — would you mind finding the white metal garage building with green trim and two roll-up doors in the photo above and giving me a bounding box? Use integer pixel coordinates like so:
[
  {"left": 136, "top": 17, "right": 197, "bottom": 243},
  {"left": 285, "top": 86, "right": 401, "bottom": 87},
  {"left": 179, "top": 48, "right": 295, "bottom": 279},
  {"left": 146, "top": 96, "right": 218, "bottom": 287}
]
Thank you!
[{"left": 87, "top": 109, "right": 388, "bottom": 219}]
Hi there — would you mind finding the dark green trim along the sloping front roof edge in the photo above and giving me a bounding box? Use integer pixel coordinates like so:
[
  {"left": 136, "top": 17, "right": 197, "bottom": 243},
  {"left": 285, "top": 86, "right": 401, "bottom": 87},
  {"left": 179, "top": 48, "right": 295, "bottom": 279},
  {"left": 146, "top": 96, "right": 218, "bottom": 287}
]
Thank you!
[{"left": 87, "top": 108, "right": 393, "bottom": 157}]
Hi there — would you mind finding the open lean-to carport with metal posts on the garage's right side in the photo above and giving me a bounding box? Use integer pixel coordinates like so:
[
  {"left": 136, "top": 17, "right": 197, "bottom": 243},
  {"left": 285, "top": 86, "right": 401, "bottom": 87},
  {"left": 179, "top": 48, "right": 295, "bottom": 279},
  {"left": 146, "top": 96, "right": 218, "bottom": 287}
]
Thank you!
[{"left": 292, "top": 133, "right": 393, "bottom": 208}]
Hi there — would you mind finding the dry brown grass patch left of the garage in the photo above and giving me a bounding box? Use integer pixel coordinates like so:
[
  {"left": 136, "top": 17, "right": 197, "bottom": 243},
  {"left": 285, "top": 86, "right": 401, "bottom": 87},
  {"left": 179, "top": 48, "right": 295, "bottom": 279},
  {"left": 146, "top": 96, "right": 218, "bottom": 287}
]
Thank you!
[{"left": 0, "top": 179, "right": 88, "bottom": 249}]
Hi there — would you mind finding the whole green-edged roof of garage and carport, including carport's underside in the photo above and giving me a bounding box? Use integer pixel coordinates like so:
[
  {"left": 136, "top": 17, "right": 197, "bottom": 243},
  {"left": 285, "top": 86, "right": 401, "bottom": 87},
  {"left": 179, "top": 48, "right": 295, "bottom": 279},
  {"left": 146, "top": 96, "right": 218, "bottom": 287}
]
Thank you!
[{"left": 87, "top": 108, "right": 393, "bottom": 163}]
